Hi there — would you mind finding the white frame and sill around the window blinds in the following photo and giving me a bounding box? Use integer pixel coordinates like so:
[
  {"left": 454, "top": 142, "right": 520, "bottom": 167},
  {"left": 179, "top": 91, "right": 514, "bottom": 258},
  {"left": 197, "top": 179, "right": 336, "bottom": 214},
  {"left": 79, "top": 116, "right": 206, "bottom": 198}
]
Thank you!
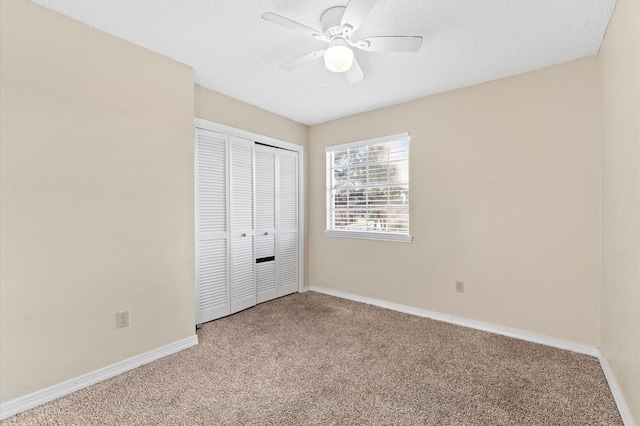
[{"left": 324, "top": 133, "right": 413, "bottom": 243}]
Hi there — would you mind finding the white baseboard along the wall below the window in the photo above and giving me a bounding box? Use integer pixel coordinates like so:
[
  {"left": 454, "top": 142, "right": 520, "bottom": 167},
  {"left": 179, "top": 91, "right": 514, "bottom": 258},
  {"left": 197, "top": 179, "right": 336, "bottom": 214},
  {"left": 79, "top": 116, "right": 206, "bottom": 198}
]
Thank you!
[{"left": 310, "top": 285, "right": 599, "bottom": 357}]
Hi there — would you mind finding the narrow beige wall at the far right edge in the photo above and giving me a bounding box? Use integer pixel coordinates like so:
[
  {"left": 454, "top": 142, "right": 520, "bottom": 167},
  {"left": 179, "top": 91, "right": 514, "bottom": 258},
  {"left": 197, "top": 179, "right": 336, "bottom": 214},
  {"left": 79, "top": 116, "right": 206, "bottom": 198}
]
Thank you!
[{"left": 598, "top": 0, "right": 640, "bottom": 425}]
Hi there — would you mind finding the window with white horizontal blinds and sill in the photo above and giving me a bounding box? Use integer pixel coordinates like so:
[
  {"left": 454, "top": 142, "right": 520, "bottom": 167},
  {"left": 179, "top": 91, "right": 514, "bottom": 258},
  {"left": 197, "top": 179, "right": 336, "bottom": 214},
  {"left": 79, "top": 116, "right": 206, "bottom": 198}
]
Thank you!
[{"left": 325, "top": 133, "right": 411, "bottom": 242}]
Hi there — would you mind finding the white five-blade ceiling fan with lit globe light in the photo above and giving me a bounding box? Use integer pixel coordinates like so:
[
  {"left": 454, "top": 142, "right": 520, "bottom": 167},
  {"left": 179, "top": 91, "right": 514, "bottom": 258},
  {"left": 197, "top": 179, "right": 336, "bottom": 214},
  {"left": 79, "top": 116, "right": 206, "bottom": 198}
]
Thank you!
[{"left": 262, "top": 0, "right": 422, "bottom": 83}]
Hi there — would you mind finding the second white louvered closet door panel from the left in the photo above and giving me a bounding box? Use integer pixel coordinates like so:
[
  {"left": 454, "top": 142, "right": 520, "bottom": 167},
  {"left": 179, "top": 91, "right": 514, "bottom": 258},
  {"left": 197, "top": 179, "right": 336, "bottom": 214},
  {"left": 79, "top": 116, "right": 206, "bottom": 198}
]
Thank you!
[{"left": 229, "top": 136, "right": 256, "bottom": 313}]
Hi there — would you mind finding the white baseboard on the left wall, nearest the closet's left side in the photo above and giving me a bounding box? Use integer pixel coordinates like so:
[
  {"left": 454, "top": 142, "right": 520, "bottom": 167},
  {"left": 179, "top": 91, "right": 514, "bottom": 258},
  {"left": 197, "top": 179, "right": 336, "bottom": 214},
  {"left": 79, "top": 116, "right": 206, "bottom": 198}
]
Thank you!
[{"left": 0, "top": 335, "right": 198, "bottom": 420}]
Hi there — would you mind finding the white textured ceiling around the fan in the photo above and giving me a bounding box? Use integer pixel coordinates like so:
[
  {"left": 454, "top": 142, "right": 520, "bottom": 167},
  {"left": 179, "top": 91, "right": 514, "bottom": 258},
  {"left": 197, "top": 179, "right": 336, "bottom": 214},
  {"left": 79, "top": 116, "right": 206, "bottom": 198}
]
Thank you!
[{"left": 32, "top": 0, "right": 615, "bottom": 125}]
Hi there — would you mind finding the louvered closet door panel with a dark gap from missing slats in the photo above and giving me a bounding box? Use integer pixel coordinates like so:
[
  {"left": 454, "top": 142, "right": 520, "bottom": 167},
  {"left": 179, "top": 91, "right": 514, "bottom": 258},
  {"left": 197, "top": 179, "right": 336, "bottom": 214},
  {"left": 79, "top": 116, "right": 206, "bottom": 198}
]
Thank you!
[{"left": 255, "top": 145, "right": 278, "bottom": 303}]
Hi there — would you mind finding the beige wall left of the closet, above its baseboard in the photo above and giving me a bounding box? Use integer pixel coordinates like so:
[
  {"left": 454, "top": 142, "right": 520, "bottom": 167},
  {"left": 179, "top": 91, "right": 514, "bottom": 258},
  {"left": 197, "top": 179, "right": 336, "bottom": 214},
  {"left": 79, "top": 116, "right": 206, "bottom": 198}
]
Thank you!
[{"left": 0, "top": 0, "right": 195, "bottom": 402}]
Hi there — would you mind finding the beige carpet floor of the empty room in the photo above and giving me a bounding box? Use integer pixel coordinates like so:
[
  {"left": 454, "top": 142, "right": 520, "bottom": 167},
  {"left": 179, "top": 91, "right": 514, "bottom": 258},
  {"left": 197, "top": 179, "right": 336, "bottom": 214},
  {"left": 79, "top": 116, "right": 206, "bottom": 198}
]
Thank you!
[{"left": 2, "top": 292, "right": 622, "bottom": 426}]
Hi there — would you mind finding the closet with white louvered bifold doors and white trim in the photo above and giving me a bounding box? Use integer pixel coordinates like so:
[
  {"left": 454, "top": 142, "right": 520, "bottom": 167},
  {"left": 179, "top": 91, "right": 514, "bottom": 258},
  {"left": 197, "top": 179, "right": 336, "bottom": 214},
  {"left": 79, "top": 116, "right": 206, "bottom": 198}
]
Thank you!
[{"left": 195, "top": 127, "right": 301, "bottom": 324}]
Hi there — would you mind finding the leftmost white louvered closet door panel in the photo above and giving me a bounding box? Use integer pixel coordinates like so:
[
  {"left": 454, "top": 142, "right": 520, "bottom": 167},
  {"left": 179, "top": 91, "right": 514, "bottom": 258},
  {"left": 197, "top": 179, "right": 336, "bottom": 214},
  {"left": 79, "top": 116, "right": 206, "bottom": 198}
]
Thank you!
[{"left": 195, "top": 129, "right": 231, "bottom": 324}]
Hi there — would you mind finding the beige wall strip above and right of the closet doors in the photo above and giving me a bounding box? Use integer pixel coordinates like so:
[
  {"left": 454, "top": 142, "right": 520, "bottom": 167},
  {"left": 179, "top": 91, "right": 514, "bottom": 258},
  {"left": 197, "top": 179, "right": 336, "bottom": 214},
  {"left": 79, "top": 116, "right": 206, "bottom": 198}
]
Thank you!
[{"left": 194, "top": 85, "right": 309, "bottom": 285}]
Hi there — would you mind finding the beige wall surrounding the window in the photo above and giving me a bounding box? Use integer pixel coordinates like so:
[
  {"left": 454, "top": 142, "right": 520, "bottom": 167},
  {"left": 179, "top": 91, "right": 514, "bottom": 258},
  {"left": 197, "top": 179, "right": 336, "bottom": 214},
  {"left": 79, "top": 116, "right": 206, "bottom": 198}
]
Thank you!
[{"left": 309, "top": 58, "right": 600, "bottom": 345}]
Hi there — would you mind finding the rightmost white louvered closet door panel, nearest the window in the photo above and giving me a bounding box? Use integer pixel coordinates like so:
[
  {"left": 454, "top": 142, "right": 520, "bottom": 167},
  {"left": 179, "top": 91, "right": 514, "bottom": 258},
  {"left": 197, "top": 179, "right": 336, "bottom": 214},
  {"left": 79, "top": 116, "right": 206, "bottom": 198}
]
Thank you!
[{"left": 276, "top": 150, "right": 299, "bottom": 296}]
